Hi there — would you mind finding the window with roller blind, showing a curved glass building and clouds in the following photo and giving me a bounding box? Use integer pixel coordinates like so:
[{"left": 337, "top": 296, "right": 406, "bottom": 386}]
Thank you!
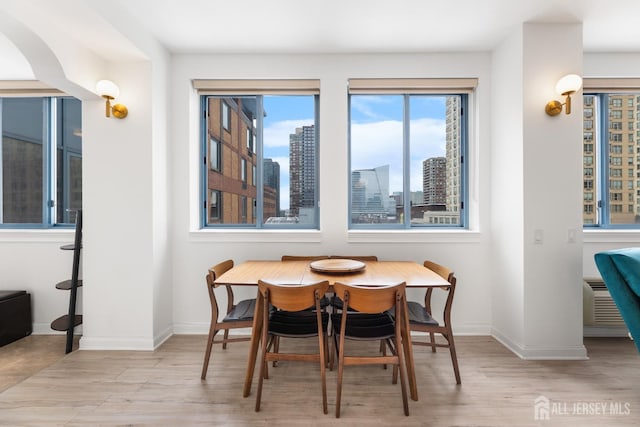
[{"left": 349, "top": 79, "right": 475, "bottom": 228}]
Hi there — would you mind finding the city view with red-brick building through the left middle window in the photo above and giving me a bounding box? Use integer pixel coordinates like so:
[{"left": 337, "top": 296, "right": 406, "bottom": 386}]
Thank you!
[{"left": 206, "top": 95, "right": 318, "bottom": 227}]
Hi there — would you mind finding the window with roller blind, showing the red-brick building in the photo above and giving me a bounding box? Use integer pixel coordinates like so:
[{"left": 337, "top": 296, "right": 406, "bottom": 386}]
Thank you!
[{"left": 194, "top": 80, "right": 319, "bottom": 229}]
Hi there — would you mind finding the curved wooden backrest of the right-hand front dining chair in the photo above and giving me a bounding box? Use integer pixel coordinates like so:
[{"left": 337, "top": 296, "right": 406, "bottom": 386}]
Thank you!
[{"left": 333, "top": 282, "right": 406, "bottom": 313}]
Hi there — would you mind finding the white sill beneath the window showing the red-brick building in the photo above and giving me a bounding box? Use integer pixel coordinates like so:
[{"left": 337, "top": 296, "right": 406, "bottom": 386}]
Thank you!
[{"left": 189, "top": 229, "right": 322, "bottom": 243}]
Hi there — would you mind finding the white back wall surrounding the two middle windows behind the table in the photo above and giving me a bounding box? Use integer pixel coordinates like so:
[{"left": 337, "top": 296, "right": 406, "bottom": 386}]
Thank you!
[{"left": 172, "top": 53, "right": 491, "bottom": 334}]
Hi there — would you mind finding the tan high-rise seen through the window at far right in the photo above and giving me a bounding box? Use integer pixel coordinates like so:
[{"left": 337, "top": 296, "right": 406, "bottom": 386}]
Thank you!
[{"left": 582, "top": 94, "right": 640, "bottom": 224}]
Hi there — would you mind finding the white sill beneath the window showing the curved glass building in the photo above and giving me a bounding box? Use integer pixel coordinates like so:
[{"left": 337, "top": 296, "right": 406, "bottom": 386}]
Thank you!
[{"left": 347, "top": 229, "right": 481, "bottom": 243}]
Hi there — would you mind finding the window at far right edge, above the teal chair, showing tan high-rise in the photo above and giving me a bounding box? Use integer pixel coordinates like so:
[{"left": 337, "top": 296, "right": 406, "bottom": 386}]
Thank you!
[{"left": 582, "top": 79, "right": 640, "bottom": 228}]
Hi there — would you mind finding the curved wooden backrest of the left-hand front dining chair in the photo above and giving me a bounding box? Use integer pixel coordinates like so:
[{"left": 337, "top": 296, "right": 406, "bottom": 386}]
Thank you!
[{"left": 258, "top": 280, "right": 329, "bottom": 311}]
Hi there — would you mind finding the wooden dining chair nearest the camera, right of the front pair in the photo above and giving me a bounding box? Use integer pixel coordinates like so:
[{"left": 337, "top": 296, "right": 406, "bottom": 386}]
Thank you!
[{"left": 331, "top": 282, "right": 412, "bottom": 418}]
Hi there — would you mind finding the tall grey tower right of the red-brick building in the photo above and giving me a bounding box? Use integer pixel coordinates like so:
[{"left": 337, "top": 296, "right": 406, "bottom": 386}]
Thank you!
[{"left": 289, "top": 125, "right": 316, "bottom": 216}]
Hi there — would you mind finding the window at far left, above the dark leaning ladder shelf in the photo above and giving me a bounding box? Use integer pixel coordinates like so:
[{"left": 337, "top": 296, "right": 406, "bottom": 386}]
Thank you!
[{"left": 0, "top": 97, "right": 82, "bottom": 227}]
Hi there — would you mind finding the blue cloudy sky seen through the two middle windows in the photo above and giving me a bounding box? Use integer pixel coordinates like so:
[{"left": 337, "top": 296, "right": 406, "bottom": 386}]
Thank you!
[{"left": 264, "top": 95, "right": 445, "bottom": 208}]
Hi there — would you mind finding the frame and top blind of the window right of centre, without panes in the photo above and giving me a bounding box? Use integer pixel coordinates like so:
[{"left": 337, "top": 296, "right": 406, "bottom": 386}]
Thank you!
[{"left": 347, "top": 78, "right": 477, "bottom": 231}]
